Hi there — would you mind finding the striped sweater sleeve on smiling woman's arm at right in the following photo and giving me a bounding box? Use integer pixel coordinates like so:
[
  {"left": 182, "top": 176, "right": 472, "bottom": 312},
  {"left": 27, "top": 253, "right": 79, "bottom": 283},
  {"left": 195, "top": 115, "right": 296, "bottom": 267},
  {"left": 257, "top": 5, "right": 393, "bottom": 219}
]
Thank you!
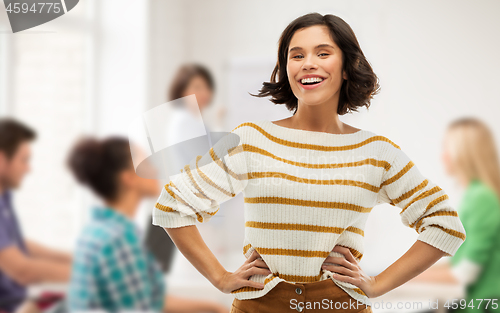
[{"left": 378, "top": 142, "right": 465, "bottom": 256}]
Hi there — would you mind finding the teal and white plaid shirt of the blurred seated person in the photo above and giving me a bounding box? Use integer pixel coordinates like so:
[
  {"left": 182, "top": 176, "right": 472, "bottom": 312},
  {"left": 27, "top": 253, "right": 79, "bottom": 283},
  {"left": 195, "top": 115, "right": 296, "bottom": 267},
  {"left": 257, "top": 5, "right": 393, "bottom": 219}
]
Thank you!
[{"left": 69, "top": 207, "right": 165, "bottom": 311}]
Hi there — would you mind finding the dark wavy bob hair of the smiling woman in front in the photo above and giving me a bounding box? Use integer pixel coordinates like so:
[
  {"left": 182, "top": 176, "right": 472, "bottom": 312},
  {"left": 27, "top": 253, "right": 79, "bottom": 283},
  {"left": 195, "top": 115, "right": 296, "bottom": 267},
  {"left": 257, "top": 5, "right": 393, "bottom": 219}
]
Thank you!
[{"left": 250, "top": 13, "right": 380, "bottom": 115}]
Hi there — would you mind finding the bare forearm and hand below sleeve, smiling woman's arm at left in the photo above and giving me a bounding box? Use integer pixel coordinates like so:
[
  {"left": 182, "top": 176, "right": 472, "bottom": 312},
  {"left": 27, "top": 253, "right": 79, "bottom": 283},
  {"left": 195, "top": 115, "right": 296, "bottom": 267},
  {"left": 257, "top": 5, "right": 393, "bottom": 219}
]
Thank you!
[{"left": 165, "top": 225, "right": 271, "bottom": 293}]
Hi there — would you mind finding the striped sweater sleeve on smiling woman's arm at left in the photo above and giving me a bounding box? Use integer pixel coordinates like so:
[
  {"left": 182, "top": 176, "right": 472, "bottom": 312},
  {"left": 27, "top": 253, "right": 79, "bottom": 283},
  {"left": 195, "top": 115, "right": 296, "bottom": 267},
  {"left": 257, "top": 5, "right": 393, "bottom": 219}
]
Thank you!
[{"left": 153, "top": 126, "right": 248, "bottom": 228}]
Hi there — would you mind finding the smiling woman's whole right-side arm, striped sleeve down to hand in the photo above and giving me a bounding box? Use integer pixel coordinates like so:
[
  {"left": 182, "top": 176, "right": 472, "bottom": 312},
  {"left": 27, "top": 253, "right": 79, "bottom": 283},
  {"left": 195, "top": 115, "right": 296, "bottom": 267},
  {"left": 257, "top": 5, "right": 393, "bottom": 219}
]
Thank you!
[{"left": 324, "top": 140, "right": 465, "bottom": 297}]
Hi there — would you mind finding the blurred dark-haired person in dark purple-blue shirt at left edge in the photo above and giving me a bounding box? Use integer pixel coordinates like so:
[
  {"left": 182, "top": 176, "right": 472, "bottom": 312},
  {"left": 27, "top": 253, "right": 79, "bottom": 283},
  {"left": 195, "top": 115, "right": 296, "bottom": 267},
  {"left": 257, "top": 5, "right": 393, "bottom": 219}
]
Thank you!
[{"left": 0, "top": 118, "right": 72, "bottom": 312}]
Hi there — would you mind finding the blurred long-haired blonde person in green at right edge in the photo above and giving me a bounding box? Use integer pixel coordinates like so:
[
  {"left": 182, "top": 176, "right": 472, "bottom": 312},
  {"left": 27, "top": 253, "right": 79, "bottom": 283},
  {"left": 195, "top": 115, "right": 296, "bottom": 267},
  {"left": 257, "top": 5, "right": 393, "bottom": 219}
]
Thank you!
[{"left": 413, "top": 117, "right": 500, "bottom": 312}]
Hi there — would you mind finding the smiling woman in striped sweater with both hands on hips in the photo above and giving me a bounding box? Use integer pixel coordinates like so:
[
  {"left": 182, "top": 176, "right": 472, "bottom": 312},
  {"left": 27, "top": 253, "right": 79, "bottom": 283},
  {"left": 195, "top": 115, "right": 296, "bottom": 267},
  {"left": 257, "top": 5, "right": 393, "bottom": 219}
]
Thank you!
[{"left": 153, "top": 13, "right": 466, "bottom": 313}]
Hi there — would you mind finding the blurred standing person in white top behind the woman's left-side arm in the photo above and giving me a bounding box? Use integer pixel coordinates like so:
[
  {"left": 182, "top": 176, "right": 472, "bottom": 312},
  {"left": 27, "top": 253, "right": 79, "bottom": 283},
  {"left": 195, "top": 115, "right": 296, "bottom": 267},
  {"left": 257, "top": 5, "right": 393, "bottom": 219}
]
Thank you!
[{"left": 148, "top": 62, "right": 233, "bottom": 294}]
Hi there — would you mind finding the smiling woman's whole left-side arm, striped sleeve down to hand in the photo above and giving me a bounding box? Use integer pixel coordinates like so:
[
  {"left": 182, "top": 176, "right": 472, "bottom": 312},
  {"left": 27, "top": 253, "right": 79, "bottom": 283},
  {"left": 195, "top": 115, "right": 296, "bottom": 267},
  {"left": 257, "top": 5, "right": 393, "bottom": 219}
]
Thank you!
[{"left": 153, "top": 126, "right": 271, "bottom": 293}]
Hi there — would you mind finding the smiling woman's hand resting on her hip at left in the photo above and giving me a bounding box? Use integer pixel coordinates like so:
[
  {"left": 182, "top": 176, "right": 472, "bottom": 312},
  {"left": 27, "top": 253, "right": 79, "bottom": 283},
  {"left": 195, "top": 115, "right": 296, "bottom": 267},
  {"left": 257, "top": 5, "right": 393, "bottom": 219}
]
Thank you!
[{"left": 216, "top": 250, "right": 272, "bottom": 293}]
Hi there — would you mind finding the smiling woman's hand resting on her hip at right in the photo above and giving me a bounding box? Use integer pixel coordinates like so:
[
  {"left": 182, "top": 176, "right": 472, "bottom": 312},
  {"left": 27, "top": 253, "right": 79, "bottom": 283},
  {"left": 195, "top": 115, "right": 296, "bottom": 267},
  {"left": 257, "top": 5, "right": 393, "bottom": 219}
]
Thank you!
[{"left": 321, "top": 245, "right": 379, "bottom": 298}]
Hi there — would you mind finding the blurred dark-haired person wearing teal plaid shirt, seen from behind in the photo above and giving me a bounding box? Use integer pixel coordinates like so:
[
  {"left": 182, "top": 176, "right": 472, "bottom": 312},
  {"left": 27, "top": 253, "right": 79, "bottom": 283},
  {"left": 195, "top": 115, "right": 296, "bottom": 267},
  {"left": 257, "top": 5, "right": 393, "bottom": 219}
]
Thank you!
[{"left": 67, "top": 137, "right": 228, "bottom": 313}]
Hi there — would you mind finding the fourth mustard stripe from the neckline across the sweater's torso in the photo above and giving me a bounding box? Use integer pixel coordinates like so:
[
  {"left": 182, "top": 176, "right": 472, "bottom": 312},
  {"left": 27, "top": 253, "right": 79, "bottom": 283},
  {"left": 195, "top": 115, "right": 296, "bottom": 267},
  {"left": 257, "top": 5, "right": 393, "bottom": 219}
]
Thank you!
[{"left": 244, "top": 197, "right": 372, "bottom": 213}]
